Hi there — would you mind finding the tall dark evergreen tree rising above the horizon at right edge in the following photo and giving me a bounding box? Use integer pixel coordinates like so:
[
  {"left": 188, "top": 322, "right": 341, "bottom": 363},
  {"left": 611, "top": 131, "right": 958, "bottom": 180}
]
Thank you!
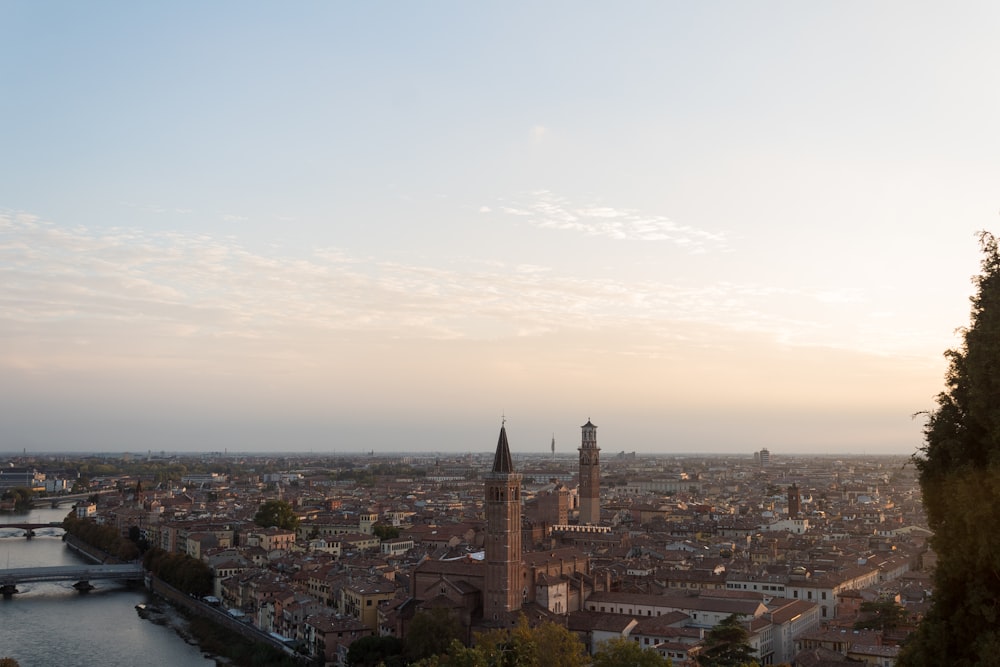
[{"left": 897, "top": 232, "right": 1000, "bottom": 667}]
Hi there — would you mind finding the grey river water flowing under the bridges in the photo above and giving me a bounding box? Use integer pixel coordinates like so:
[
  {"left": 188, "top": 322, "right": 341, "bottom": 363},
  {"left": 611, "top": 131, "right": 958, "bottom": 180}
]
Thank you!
[{"left": 0, "top": 508, "right": 215, "bottom": 667}]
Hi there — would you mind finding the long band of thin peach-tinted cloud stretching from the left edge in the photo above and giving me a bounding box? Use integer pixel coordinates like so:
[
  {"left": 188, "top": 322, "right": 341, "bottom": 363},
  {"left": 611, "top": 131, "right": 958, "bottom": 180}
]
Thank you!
[{"left": 0, "top": 208, "right": 939, "bottom": 374}]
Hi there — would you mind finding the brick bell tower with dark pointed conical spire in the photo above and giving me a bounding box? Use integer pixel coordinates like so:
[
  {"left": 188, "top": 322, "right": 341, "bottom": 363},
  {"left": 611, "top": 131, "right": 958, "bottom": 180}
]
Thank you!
[{"left": 483, "top": 424, "right": 522, "bottom": 622}]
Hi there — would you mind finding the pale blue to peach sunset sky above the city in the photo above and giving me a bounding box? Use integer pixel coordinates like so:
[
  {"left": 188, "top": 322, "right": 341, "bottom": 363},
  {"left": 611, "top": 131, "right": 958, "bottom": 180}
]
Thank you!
[{"left": 0, "top": 0, "right": 1000, "bottom": 457}]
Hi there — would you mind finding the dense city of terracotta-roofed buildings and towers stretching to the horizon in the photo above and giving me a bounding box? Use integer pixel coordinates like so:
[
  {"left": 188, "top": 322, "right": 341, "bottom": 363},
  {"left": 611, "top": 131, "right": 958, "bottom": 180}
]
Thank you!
[{"left": 0, "top": 420, "right": 935, "bottom": 667}]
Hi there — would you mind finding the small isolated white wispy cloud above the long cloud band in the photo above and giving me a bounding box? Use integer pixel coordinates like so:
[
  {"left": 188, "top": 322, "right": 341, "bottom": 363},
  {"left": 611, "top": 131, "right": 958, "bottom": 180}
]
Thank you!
[{"left": 492, "top": 190, "right": 727, "bottom": 253}]
